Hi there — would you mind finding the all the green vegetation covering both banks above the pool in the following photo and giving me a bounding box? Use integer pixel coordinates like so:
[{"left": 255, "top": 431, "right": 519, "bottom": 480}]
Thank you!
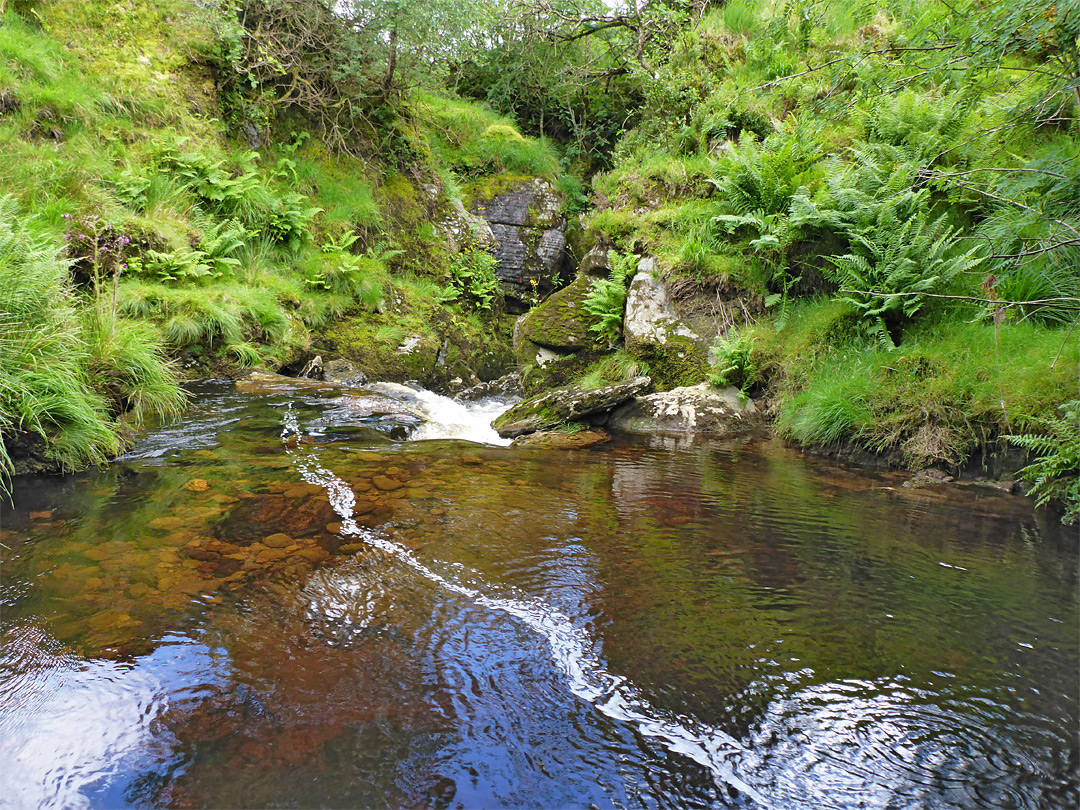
[{"left": 0, "top": 0, "right": 1080, "bottom": 514}]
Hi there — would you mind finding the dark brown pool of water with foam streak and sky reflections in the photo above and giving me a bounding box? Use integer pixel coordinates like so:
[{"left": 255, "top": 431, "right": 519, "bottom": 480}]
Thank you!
[{"left": 0, "top": 388, "right": 1080, "bottom": 810}]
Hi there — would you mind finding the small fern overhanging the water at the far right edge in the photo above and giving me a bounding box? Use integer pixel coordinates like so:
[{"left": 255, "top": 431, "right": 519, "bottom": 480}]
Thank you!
[{"left": 1005, "top": 400, "right": 1080, "bottom": 524}]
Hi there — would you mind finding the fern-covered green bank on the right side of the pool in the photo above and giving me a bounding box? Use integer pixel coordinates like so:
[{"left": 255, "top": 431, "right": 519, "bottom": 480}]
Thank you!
[{"left": 565, "top": 0, "right": 1080, "bottom": 516}]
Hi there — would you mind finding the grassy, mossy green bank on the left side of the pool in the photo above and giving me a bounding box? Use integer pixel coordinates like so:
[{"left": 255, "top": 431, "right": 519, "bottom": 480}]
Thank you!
[{"left": 0, "top": 0, "right": 580, "bottom": 477}]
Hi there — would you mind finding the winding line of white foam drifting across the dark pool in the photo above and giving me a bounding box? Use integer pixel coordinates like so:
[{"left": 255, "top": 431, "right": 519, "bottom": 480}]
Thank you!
[{"left": 282, "top": 408, "right": 772, "bottom": 808}]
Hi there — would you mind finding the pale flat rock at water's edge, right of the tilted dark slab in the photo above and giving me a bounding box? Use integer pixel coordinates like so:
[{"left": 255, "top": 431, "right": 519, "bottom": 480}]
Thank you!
[{"left": 607, "top": 382, "right": 758, "bottom": 435}]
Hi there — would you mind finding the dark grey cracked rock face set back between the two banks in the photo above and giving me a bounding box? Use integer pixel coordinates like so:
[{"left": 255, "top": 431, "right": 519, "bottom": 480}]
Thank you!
[{"left": 470, "top": 177, "right": 568, "bottom": 312}]
